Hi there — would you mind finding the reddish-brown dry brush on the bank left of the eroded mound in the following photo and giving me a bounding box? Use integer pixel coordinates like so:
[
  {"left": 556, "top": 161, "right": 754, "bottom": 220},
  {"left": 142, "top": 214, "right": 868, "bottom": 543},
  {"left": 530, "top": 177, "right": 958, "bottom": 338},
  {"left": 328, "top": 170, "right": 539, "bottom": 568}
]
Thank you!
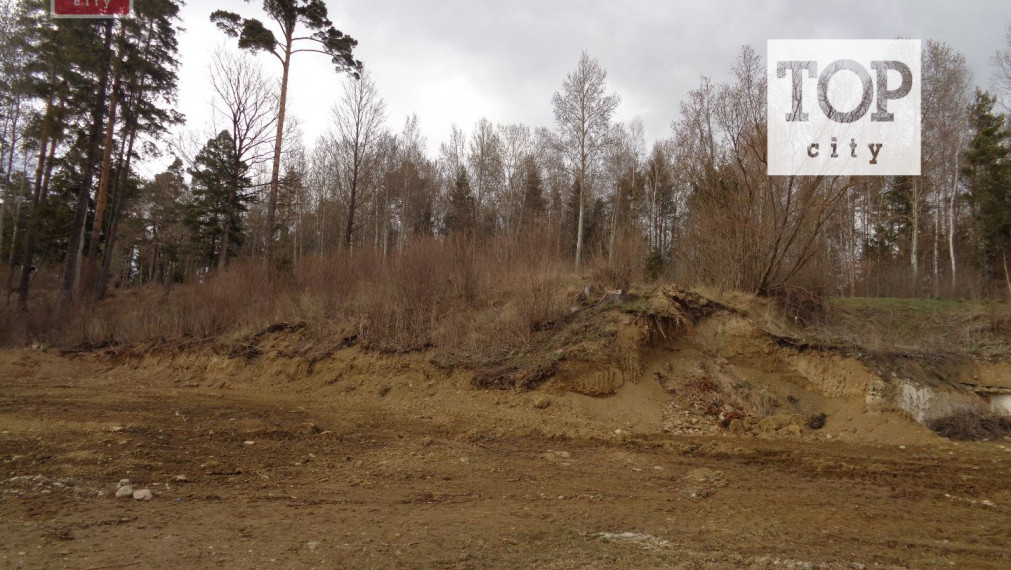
[{"left": 0, "top": 238, "right": 594, "bottom": 362}]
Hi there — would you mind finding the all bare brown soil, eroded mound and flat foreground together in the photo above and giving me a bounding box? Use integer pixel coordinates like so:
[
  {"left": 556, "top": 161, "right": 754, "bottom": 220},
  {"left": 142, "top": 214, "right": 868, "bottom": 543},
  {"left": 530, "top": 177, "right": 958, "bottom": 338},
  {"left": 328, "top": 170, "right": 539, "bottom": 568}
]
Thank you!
[{"left": 0, "top": 289, "right": 1011, "bottom": 568}]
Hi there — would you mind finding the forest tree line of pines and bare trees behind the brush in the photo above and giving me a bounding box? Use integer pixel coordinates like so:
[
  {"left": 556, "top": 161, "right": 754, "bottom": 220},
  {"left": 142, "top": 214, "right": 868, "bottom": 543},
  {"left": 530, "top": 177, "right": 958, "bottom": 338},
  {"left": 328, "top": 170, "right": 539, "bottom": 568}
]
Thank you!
[{"left": 0, "top": 0, "right": 1011, "bottom": 309}]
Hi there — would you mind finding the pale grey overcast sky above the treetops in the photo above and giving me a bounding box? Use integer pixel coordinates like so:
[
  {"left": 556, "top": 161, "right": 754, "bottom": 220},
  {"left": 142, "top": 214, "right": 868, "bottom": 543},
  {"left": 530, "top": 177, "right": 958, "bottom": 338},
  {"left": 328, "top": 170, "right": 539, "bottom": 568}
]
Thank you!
[{"left": 153, "top": 0, "right": 1011, "bottom": 172}]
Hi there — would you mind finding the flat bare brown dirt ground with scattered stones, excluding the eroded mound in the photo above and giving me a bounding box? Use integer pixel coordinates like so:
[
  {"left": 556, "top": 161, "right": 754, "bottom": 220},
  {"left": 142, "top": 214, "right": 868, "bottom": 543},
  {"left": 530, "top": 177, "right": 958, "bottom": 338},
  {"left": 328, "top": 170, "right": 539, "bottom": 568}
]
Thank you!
[{"left": 0, "top": 350, "right": 1011, "bottom": 570}]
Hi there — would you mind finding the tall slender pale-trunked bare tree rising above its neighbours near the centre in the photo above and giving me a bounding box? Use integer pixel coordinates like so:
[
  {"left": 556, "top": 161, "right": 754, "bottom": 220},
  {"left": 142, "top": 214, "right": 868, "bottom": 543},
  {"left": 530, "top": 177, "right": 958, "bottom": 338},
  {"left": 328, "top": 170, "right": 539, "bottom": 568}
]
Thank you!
[{"left": 551, "top": 52, "right": 621, "bottom": 271}]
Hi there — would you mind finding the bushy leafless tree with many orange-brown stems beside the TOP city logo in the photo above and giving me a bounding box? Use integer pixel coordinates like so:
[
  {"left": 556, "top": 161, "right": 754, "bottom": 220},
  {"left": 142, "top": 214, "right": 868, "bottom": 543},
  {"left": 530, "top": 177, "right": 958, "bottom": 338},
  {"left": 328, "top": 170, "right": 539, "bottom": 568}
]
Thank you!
[{"left": 675, "top": 46, "right": 851, "bottom": 293}]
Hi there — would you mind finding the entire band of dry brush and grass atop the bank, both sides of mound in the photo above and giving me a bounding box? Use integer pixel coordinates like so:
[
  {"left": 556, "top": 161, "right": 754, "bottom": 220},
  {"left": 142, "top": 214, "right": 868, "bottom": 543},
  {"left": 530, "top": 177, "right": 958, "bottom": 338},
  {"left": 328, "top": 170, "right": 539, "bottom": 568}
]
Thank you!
[{"left": 11, "top": 233, "right": 1011, "bottom": 382}]
